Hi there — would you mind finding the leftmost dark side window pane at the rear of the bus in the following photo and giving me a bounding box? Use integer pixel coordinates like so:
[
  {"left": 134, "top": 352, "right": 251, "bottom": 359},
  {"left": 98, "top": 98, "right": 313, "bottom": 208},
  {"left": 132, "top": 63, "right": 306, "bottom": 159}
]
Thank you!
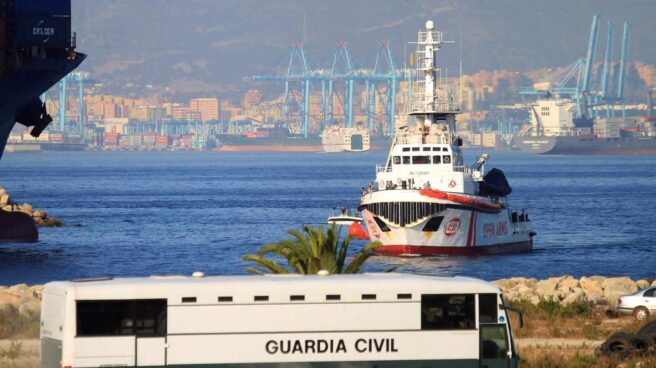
[{"left": 77, "top": 300, "right": 134, "bottom": 336}]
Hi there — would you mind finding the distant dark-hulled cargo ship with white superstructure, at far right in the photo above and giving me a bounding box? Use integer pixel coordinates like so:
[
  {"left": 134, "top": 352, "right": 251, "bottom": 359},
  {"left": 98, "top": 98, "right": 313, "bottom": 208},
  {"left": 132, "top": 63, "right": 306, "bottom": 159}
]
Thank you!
[{"left": 514, "top": 98, "right": 656, "bottom": 155}]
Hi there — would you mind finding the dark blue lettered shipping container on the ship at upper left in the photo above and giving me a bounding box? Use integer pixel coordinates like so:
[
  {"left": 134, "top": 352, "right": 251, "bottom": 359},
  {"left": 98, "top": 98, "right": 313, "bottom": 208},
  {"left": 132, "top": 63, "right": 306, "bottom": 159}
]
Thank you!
[{"left": 16, "top": 15, "right": 71, "bottom": 49}]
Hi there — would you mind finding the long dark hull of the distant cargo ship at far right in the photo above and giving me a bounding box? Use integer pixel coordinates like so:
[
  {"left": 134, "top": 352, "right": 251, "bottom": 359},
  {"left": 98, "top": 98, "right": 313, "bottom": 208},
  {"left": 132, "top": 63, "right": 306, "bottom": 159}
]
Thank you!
[{"left": 515, "top": 136, "right": 656, "bottom": 155}]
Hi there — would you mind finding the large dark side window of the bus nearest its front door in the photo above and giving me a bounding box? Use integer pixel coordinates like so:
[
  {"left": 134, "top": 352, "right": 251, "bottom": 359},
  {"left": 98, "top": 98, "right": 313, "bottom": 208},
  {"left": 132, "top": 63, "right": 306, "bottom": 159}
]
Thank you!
[{"left": 421, "top": 294, "right": 476, "bottom": 330}]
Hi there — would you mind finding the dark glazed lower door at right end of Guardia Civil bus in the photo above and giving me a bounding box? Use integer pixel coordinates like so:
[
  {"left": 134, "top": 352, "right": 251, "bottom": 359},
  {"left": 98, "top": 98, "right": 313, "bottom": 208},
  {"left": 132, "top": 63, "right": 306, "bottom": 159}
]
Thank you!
[{"left": 479, "top": 323, "right": 511, "bottom": 368}]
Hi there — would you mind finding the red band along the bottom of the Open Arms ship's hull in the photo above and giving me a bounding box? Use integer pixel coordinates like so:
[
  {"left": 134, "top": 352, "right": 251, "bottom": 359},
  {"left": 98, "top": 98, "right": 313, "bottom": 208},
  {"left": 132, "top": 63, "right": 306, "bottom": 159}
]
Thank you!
[{"left": 376, "top": 240, "right": 533, "bottom": 256}]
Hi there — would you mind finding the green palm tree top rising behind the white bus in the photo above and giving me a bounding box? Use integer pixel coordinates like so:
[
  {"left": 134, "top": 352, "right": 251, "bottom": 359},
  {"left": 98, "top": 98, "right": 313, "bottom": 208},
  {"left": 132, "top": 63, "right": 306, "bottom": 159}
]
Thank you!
[{"left": 242, "top": 224, "right": 382, "bottom": 275}]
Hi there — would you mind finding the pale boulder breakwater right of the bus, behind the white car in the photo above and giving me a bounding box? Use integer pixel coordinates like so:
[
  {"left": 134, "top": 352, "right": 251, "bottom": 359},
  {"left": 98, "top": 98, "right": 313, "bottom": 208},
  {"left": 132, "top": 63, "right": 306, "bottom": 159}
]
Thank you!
[{"left": 492, "top": 276, "right": 656, "bottom": 308}]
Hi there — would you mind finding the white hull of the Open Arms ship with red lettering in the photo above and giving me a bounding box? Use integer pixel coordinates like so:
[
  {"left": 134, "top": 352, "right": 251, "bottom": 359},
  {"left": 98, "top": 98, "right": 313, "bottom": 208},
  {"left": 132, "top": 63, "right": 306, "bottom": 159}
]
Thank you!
[{"left": 362, "top": 190, "right": 533, "bottom": 256}]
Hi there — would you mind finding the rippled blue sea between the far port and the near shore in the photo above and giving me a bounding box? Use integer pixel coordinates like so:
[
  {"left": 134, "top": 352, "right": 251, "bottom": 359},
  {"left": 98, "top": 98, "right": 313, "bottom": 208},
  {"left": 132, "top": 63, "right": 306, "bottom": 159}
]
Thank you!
[{"left": 0, "top": 151, "right": 656, "bottom": 285}]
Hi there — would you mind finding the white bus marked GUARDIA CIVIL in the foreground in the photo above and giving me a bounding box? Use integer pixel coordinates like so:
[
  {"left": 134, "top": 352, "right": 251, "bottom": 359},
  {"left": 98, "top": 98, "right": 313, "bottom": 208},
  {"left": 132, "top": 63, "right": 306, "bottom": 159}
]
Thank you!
[{"left": 41, "top": 273, "right": 517, "bottom": 368}]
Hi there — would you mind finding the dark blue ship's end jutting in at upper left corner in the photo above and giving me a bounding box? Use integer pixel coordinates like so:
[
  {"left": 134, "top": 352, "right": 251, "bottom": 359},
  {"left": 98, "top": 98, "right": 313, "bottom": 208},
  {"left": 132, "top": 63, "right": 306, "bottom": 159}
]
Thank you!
[{"left": 0, "top": 0, "right": 86, "bottom": 157}]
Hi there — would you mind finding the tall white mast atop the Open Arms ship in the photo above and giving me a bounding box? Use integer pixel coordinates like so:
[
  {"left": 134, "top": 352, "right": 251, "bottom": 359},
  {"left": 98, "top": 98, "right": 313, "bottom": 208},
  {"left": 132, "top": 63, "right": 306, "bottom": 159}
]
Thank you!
[{"left": 410, "top": 20, "right": 460, "bottom": 138}]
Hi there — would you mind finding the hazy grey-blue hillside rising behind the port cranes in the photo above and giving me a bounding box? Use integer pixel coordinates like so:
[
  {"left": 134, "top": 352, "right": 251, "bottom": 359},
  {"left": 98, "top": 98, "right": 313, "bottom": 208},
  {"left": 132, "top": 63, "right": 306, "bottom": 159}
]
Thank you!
[{"left": 73, "top": 0, "right": 656, "bottom": 96}]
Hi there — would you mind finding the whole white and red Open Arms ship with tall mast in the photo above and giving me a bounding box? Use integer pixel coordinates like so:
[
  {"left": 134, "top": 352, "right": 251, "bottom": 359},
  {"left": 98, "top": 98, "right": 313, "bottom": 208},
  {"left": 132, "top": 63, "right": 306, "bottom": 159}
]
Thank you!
[{"left": 349, "top": 21, "right": 535, "bottom": 256}]
